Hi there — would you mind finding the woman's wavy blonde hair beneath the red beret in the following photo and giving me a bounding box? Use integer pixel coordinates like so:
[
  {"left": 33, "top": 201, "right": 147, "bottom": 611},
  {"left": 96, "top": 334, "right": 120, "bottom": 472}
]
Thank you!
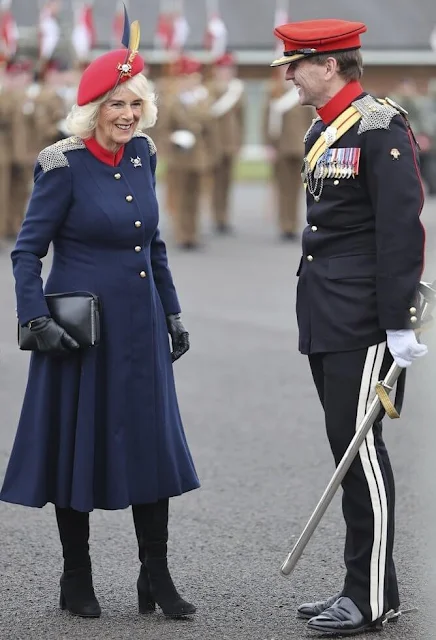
[{"left": 67, "top": 73, "right": 157, "bottom": 139}]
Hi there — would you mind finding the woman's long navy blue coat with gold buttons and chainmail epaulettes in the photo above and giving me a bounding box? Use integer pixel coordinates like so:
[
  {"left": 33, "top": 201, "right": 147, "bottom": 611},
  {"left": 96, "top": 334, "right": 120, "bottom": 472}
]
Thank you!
[{"left": 0, "top": 133, "right": 199, "bottom": 512}]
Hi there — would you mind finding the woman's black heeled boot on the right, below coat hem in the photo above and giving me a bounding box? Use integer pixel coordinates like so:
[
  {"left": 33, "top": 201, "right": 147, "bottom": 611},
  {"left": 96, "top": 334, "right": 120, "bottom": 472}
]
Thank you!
[{"left": 132, "top": 500, "right": 196, "bottom": 618}]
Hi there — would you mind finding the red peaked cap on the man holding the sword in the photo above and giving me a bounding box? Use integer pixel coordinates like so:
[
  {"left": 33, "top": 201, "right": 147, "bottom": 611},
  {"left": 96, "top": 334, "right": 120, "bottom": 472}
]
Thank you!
[{"left": 271, "top": 19, "right": 366, "bottom": 67}]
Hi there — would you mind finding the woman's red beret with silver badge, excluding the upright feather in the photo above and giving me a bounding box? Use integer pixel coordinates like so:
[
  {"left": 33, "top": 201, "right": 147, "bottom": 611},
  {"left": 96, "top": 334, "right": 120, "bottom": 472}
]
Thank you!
[{"left": 77, "top": 49, "right": 145, "bottom": 107}]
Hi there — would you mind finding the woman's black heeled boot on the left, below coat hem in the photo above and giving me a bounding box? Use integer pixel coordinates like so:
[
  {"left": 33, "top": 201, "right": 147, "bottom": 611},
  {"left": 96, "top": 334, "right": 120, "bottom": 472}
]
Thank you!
[{"left": 56, "top": 507, "right": 101, "bottom": 618}]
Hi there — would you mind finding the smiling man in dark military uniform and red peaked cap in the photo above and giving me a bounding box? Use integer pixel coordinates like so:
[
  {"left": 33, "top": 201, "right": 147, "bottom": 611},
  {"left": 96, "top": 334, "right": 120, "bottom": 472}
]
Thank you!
[{"left": 272, "top": 20, "right": 427, "bottom": 635}]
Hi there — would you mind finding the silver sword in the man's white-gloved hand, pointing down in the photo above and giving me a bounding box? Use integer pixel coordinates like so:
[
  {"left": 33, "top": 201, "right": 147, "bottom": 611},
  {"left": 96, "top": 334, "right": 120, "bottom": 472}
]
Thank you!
[{"left": 280, "top": 280, "right": 436, "bottom": 576}]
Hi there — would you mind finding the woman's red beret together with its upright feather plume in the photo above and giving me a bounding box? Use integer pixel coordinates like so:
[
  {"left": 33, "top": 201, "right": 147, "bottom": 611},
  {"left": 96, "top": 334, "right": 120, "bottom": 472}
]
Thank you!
[{"left": 77, "top": 6, "right": 145, "bottom": 107}]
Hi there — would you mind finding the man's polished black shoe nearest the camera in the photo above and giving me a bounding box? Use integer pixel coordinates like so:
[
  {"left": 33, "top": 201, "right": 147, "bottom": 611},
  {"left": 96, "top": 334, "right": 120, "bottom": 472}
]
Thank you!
[{"left": 307, "top": 597, "right": 382, "bottom": 636}]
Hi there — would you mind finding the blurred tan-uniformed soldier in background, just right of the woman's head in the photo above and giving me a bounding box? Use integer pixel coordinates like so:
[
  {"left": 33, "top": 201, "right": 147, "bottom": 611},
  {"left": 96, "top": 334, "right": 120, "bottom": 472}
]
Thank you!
[{"left": 167, "top": 56, "right": 218, "bottom": 249}]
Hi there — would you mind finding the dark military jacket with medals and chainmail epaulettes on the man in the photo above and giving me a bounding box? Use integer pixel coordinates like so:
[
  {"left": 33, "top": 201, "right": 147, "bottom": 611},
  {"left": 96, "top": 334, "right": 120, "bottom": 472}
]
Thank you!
[{"left": 297, "top": 94, "right": 424, "bottom": 354}]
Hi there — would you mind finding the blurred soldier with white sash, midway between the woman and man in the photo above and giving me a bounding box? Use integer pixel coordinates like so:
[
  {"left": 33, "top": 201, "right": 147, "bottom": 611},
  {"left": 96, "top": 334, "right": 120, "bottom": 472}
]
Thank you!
[{"left": 208, "top": 53, "right": 245, "bottom": 233}]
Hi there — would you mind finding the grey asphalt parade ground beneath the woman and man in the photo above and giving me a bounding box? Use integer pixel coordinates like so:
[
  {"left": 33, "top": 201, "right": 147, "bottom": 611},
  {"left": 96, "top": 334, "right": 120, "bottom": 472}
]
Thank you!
[{"left": 0, "top": 184, "right": 436, "bottom": 640}]
